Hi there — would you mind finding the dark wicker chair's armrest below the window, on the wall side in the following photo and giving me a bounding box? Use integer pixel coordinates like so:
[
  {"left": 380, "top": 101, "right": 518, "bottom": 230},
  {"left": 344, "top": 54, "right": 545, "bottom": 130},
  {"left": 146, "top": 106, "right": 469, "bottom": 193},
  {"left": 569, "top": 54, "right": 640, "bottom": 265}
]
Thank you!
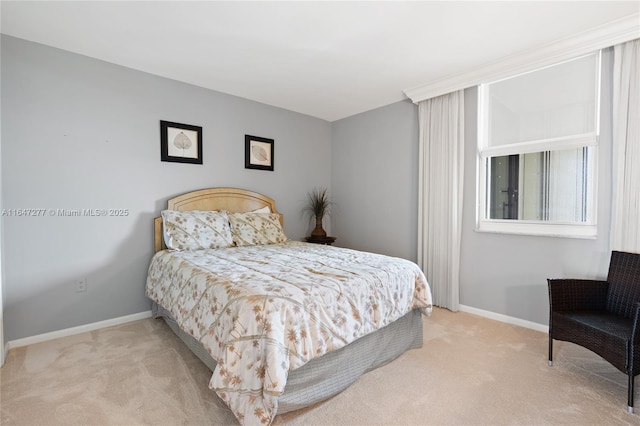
[{"left": 547, "top": 279, "right": 609, "bottom": 312}]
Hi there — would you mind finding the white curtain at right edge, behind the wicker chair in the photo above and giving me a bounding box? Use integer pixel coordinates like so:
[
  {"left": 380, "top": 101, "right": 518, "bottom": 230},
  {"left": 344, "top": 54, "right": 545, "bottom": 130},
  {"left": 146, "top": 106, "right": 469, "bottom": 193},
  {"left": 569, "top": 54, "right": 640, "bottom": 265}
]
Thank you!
[{"left": 611, "top": 39, "right": 640, "bottom": 253}]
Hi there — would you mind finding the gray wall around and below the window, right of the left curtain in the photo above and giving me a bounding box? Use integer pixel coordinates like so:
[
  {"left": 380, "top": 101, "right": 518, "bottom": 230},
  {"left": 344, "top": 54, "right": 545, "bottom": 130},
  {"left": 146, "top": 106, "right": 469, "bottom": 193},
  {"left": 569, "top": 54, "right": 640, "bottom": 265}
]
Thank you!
[{"left": 460, "top": 88, "right": 611, "bottom": 324}]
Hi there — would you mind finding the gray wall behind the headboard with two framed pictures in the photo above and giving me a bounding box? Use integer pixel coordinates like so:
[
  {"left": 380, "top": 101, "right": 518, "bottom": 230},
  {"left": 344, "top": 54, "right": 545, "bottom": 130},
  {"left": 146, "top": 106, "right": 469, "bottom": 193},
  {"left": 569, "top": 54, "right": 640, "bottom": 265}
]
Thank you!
[{"left": 1, "top": 36, "right": 331, "bottom": 341}]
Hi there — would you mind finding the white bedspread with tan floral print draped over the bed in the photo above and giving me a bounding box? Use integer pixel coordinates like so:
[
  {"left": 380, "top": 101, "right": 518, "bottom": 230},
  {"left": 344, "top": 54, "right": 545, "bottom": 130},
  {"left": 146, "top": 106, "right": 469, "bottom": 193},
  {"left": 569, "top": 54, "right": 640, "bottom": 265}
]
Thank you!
[{"left": 147, "top": 241, "right": 431, "bottom": 425}]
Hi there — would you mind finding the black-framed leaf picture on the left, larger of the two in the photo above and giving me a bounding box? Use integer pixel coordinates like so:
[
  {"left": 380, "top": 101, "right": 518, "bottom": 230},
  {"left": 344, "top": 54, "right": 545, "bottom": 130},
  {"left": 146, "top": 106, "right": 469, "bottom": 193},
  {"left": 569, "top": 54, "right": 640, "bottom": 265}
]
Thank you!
[{"left": 160, "top": 120, "right": 202, "bottom": 164}]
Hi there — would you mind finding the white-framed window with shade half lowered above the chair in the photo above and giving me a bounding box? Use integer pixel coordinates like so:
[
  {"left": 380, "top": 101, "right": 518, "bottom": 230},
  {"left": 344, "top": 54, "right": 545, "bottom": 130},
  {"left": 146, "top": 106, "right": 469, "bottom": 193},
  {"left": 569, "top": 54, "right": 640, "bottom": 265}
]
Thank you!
[{"left": 477, "top": 53, "right": 600, "bottom": 238}]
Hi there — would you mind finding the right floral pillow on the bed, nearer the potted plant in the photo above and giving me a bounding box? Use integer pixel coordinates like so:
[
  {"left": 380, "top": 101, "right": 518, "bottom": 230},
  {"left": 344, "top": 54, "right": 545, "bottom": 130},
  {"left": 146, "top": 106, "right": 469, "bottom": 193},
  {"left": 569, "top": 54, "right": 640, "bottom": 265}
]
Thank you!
[{"left": 229, "top": 212, "right": 288, "bottom": 246}]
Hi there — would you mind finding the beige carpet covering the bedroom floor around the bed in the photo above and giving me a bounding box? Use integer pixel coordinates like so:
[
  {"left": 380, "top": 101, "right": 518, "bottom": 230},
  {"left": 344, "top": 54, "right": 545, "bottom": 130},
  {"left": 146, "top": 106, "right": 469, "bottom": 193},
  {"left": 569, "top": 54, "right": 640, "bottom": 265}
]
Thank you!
[{"left": 0, "top": 309, "right": 640, "bottom": 425}]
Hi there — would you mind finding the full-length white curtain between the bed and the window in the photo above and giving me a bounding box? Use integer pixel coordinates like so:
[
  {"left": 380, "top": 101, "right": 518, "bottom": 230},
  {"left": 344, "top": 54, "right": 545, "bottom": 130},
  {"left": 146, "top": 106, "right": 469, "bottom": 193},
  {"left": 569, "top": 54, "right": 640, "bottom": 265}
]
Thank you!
[{"left": 418, "top": 90, "right": 464, "bottom": 311}]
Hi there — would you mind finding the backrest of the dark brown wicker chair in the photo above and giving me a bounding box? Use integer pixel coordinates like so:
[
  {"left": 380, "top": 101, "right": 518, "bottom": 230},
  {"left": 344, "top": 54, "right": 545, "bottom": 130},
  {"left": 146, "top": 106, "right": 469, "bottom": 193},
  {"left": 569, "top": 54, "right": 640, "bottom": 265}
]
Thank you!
[{"left": 607, "top": 251, "right": 640, "bottom": 318}]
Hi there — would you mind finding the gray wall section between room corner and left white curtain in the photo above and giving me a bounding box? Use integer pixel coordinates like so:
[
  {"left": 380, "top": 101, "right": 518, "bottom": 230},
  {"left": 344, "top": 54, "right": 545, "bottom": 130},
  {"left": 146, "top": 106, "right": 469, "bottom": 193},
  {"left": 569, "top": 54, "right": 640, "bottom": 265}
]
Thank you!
[{"left": 331, "top": 100, "right": 418, "bottom": 261}]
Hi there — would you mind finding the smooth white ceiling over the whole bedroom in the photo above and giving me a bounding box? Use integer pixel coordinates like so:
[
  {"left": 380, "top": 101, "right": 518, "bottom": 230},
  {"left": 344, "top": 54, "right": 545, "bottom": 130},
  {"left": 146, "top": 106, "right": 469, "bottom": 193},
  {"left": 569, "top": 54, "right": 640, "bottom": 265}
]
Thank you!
[{"left": 1, "top": 1, "right": 640, "bottom": 121}]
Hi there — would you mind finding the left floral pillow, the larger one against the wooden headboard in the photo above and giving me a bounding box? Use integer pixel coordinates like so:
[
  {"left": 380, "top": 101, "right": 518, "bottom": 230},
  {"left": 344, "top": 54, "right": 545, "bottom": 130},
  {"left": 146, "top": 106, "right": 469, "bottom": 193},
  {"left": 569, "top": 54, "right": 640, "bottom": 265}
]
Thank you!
[{"left": 162, "top": 210, "right": 233, "bottom": 250}]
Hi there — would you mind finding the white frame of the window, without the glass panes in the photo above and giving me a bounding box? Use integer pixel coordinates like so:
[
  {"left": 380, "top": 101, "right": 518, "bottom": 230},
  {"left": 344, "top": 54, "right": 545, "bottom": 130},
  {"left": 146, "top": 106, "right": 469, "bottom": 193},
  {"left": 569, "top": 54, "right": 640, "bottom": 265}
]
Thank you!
[{"left": 476, "top": 51, "right": 602, "bottom": 239}]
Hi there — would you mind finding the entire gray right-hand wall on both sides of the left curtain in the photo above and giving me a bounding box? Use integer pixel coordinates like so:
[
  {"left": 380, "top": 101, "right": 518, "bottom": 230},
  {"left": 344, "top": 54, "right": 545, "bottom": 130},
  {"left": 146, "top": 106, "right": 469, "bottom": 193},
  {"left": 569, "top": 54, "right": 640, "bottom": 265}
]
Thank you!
[{"left": 332, "top": 51, "right": 612, "bottom": 324}]
